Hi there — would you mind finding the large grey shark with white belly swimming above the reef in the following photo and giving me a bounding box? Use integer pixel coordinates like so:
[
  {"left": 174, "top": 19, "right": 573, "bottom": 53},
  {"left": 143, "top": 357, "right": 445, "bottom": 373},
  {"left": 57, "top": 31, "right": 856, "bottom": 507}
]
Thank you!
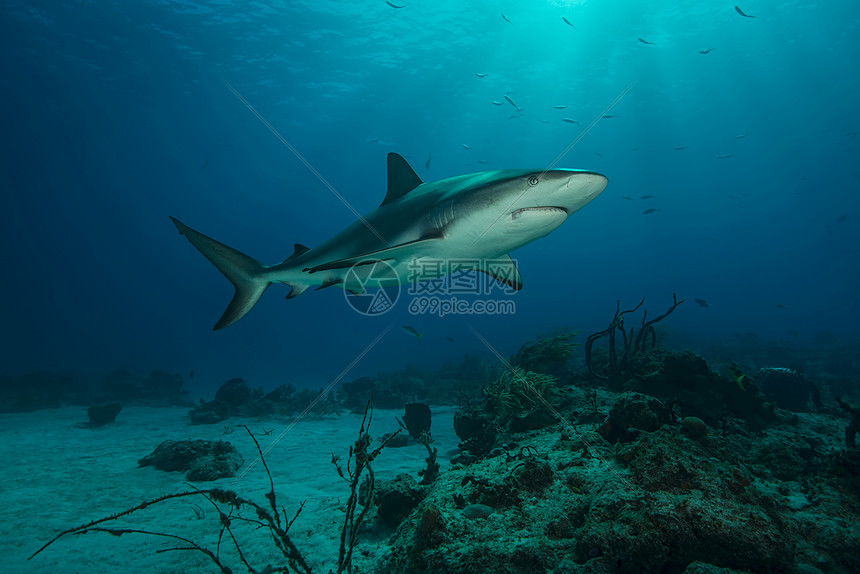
[{"left": 170, "top": 153, "right": 608, "bottom": 330}]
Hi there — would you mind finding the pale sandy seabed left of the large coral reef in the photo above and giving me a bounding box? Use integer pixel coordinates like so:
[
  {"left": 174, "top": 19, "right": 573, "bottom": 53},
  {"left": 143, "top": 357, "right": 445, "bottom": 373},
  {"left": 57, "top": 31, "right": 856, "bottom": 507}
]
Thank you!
[{"left": 0, "top": 407, "right": 458, "bottom": 574}]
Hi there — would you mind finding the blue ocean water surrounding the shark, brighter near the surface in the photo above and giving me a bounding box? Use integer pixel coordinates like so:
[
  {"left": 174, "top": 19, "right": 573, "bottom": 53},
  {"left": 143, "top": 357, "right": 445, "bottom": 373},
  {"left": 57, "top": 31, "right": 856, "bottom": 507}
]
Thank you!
[{"left": 0, "top": 0, "right": 860, "bottom": 387}]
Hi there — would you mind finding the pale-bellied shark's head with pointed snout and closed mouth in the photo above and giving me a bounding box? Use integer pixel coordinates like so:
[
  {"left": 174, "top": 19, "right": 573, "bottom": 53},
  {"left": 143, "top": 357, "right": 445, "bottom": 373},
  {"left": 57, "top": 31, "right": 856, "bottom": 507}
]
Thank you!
[{"left": 442, "top": 169, "right": 608, "bottom": 253}]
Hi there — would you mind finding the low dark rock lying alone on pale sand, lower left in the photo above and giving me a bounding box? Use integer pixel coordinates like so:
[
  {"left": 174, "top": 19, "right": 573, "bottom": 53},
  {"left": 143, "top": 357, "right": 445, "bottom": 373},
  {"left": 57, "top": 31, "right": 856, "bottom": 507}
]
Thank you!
[{"left": 137, "top": 440, "right": 244, "bottom": 481}]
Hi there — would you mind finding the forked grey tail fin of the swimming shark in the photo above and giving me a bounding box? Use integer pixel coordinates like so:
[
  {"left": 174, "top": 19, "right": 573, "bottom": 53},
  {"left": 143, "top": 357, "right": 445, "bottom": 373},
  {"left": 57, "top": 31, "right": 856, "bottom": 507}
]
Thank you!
[{"left": 170, "top": 217, "right": 270, "bottom": 331}]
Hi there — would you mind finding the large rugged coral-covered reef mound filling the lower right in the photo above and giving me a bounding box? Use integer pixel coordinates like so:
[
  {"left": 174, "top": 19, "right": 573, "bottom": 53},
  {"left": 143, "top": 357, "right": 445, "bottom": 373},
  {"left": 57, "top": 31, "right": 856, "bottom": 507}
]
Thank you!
[{"left": 374, "top": 395, "right": 860, "bottom": 574}]
